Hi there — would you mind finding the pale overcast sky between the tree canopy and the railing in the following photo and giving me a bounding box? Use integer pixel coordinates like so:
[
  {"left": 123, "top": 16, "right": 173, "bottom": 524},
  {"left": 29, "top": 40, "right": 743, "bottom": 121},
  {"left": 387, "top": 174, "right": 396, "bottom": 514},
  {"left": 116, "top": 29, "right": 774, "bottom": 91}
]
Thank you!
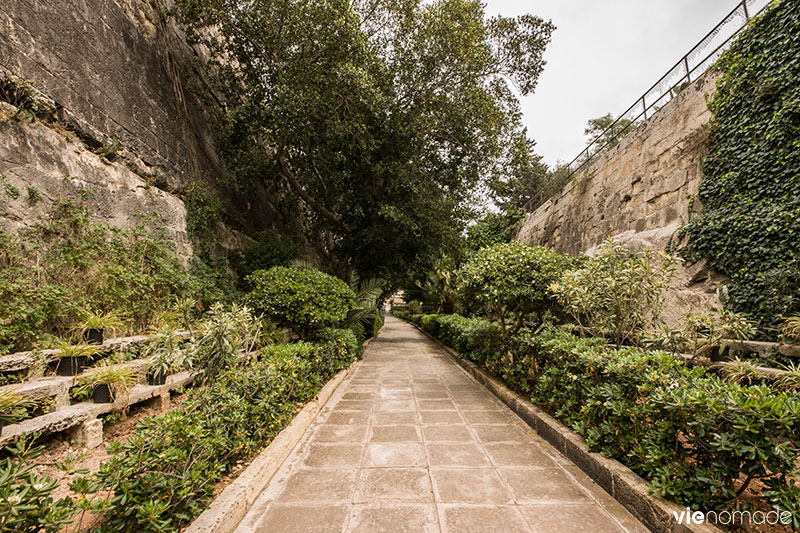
[{"left": 484, "top": 0, "right": 739, "bottom": 165}]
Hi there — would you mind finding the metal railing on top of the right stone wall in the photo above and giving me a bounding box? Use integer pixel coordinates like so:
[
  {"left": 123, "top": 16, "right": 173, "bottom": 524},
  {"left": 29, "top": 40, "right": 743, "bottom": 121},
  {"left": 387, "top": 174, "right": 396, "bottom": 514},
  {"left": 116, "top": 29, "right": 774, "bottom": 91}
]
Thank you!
[{"left": 525, "top": 0, "right": 771, "bottom": 213}]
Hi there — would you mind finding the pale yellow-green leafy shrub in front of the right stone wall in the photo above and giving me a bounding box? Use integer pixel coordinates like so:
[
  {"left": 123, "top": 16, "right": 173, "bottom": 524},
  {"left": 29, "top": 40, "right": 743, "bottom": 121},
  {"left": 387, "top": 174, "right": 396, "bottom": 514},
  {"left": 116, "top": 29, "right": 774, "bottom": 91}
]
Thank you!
[{"left": 551, "top": 240, "right": 676, "bottom": 346}]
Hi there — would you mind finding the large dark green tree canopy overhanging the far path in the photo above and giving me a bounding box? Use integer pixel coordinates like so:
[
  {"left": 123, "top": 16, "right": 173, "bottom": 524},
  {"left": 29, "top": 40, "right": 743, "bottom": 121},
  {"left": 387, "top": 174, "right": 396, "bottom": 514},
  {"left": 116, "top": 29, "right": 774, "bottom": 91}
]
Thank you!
[{"left": 178, "top": 0, "right": 554, "bottom": 278}]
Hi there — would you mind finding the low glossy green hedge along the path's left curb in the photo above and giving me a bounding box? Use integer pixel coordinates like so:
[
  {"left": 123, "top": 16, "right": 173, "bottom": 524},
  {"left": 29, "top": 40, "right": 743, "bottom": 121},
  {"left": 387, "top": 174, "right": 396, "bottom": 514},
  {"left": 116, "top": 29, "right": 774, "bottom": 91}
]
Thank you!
[{"left": 81, "top": 329, "right": 360, "bottom": 531}]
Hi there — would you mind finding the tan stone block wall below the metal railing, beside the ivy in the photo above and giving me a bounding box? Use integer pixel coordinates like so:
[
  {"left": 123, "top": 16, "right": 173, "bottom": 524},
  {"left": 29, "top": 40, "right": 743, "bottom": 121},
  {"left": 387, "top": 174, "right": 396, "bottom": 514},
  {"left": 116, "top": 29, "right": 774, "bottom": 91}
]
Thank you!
[{"left": 515, "top": 72, "right": 725, "bottom": 324}]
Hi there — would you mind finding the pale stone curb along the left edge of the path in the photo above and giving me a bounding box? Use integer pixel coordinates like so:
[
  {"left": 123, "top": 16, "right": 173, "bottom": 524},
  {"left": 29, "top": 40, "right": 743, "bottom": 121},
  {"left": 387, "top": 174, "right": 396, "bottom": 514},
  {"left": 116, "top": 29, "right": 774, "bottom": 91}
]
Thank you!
[{"left": 184, "top": 336, "right": 383, "bottom": 533}]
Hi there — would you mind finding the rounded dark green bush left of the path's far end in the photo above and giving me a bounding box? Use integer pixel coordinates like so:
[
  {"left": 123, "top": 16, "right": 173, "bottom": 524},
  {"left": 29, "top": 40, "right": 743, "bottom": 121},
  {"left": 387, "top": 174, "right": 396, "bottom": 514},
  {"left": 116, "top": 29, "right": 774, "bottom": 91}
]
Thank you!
[{"left": 246, "top": 267, "right": 355, "bottom": 338}]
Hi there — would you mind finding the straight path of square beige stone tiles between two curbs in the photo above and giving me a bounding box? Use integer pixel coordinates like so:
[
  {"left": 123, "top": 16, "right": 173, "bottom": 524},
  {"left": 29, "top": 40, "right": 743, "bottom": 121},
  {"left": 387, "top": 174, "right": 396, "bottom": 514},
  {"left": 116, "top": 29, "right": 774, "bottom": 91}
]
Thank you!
[{"left": 237, "top": 317, "right": 647, "bottom": 533}]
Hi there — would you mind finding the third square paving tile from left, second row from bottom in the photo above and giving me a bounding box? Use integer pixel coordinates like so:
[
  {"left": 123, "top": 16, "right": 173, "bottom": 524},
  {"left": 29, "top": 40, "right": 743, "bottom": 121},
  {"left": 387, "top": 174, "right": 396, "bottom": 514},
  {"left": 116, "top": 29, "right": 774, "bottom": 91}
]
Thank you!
[{"left": 431, "top": 468, "right": 514, "bottom": 504}]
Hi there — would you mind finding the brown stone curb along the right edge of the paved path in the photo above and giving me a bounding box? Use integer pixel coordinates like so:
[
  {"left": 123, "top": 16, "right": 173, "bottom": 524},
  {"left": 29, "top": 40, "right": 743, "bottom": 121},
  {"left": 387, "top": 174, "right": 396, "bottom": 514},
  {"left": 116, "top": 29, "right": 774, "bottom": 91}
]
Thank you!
[{"left": 411, "top": 324, "right": 722, "bottom": 533}]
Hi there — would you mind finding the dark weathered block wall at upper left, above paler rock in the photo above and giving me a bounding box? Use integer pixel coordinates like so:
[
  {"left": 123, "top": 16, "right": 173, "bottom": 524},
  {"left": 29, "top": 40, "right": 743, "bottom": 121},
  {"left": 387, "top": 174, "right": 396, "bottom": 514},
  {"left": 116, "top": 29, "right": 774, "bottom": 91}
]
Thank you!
[{"left": 0, "top": 0, "right": 217, "bottom": 191}]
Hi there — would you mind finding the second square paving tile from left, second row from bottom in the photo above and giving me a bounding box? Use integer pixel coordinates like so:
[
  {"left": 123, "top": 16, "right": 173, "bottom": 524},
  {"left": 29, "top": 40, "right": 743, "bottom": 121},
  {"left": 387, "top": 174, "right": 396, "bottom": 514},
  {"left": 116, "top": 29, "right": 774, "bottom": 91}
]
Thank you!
[{"left": 353, "top": 468, "right": 433, "bottom": 503}]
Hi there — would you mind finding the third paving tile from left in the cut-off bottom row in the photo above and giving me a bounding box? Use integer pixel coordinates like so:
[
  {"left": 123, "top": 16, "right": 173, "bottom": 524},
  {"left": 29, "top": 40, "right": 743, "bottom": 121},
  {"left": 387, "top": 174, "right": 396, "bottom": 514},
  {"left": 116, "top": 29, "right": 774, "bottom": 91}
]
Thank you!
[{"left": 440, "top": 505, "right": 532, "bottom": 533}]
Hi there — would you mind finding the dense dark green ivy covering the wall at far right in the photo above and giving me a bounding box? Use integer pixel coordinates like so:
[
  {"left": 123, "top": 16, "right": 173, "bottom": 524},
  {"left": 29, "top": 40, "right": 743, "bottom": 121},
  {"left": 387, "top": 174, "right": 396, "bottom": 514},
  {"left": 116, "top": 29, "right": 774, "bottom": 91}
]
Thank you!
[{"left": 682, "top": 0, "right": 800, "bottom": 337}]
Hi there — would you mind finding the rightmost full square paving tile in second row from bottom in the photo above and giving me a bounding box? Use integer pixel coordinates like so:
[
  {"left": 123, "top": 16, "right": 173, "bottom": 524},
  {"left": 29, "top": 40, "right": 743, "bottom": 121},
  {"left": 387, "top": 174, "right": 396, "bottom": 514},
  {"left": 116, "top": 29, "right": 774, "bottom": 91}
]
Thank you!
[{"left": 500, "top": 468, "right": 591, "bottom": 504}]
